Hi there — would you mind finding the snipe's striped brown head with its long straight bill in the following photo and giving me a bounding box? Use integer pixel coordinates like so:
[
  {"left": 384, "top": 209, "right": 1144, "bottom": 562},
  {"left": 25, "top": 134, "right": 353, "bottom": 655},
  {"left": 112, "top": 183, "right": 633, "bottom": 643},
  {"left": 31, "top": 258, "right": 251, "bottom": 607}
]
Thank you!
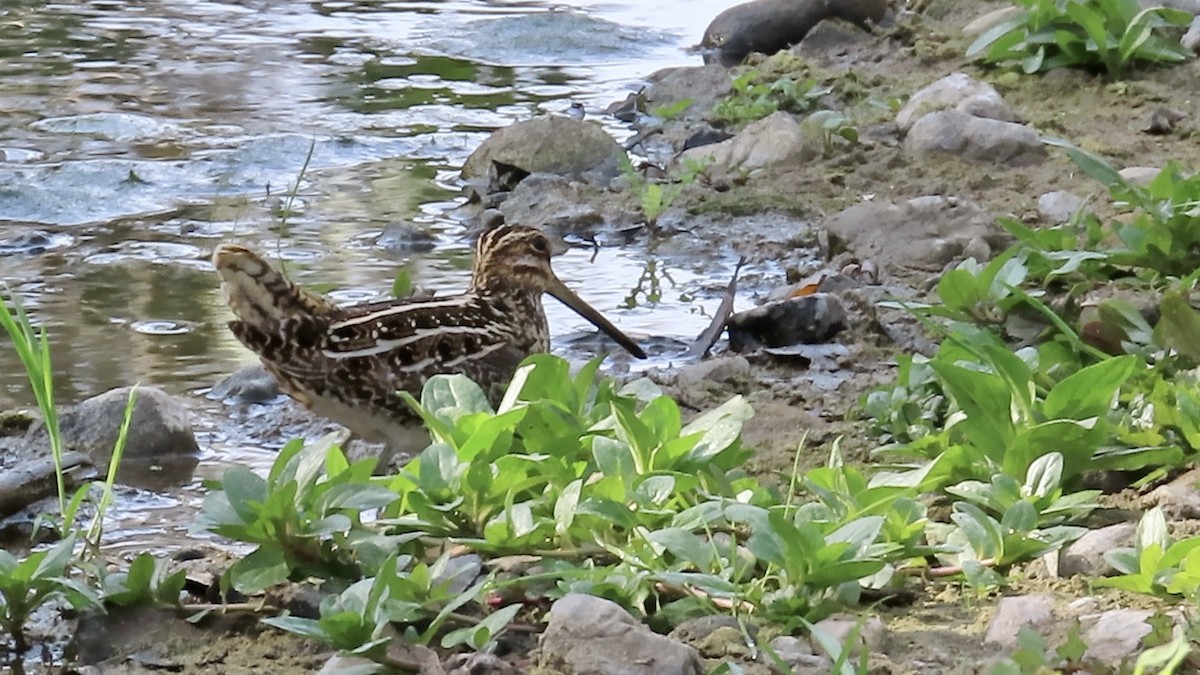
[{"left": 470, "top": 225, "right": 646, "bottom": 359}]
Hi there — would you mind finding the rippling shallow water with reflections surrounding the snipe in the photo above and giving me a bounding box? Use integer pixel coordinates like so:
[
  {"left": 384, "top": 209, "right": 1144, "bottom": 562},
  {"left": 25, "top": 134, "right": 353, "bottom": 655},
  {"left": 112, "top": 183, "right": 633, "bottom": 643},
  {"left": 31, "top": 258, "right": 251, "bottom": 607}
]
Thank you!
[{"left": 0, "top": 0, "right": 753, "bottom": 549}]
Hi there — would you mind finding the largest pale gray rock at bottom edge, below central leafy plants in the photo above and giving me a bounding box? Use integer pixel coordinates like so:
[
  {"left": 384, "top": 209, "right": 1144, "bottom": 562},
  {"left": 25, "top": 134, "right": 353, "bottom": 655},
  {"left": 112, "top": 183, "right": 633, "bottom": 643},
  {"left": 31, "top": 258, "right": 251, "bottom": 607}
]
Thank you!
[{"left": 538, "top": 593, "right": 704, "bottom": 675}]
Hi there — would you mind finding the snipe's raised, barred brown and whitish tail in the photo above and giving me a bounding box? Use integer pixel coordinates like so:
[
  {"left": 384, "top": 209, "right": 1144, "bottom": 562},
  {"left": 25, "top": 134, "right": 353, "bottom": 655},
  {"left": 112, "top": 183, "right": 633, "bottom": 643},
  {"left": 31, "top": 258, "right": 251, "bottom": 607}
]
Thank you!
[{"left": 212, "top": 244, "right": 336, "bottom": 329}]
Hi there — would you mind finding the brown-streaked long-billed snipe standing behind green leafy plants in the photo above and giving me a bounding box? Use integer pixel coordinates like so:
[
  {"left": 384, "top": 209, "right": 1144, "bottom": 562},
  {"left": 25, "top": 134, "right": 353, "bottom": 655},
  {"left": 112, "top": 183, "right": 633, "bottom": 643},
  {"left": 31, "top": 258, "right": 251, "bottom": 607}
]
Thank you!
[{"left": 212, "top": 226, "right": 646, "bottom": 466}]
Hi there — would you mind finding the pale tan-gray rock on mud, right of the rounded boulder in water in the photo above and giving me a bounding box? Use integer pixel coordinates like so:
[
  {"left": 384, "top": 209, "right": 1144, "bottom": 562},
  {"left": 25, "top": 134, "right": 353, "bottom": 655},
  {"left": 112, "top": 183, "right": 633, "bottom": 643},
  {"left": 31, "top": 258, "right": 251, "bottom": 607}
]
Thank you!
[{"left": 680, "top": 110, "right": 821, "bottom": 175}]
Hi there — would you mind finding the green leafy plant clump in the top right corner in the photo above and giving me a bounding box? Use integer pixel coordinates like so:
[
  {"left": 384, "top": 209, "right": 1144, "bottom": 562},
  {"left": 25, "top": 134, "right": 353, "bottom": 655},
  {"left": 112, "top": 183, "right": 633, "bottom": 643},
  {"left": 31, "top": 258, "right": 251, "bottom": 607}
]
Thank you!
[{"left": 967, "top": 0, "right": 1192, "bottom": 79}]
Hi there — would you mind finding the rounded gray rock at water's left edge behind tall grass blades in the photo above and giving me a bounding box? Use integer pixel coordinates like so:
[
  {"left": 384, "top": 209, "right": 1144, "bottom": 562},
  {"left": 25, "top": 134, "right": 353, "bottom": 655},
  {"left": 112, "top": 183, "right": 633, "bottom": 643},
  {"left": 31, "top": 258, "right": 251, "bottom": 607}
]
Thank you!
[{"left": 25, "top": 387, "right": 199, "bottom": 466}]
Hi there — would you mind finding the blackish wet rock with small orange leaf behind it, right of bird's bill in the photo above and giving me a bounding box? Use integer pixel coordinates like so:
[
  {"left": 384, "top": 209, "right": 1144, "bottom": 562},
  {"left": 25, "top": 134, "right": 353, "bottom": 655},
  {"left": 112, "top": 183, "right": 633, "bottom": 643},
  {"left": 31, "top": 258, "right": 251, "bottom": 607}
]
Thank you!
[{"left": 727, "top": 293, "right": 848, "bottom": 352}]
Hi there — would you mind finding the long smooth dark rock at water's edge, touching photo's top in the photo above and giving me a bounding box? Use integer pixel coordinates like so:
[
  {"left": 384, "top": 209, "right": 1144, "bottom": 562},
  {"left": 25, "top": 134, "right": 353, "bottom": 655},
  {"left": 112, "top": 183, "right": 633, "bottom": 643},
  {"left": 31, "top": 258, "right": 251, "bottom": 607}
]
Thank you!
[{"left": 700, "top": 0, "right": 888, "bottom": 65}]
